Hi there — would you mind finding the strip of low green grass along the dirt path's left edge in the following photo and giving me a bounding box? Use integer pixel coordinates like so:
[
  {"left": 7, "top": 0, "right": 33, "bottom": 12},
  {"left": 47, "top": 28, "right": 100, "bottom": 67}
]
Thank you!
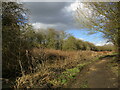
[{"left": 50, "top": 56, "right": 101, "bottom": 88}]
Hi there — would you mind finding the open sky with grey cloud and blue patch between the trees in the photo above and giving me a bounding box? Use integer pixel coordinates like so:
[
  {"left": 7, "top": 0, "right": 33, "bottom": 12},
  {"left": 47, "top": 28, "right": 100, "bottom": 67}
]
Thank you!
[{"left": 23, "top": 2, "right": 107, "bottom": 46}]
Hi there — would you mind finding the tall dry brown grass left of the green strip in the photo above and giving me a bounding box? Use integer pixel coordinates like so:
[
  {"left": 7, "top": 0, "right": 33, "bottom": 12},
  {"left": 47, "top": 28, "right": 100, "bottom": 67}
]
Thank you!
[{"left": 15, "top": 48, "right": 110, "bottom": 88}]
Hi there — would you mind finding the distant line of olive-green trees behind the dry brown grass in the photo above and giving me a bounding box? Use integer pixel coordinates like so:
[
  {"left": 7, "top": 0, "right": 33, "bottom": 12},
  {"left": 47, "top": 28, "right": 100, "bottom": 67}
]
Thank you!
[{"left": 23, "top": 26, "right": 113, "bottom": 51}]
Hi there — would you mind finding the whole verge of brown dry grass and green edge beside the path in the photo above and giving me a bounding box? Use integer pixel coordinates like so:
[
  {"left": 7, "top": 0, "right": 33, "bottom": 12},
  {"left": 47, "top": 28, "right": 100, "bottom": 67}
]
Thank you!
[{"left": 14, "top": 50, "right": 110, "bottom": 88}]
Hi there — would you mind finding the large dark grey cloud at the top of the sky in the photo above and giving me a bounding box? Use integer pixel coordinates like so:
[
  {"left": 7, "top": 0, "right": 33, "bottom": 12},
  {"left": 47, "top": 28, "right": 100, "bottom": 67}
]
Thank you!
[{"left": 24, "top": 2, "right": 76, "bottom": 29}]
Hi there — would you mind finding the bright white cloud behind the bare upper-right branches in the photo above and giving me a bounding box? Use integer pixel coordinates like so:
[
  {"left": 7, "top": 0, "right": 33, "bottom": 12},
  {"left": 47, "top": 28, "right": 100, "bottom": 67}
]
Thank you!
[{"left": 63, "top": 0, "right": 95, "bottom": 28}]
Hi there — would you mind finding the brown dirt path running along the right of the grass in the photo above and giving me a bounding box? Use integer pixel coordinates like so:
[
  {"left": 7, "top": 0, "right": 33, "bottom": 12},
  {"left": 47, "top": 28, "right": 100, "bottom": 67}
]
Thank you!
[{"left": 67, "top": 58, "right": 118, "bottom": 88}]
